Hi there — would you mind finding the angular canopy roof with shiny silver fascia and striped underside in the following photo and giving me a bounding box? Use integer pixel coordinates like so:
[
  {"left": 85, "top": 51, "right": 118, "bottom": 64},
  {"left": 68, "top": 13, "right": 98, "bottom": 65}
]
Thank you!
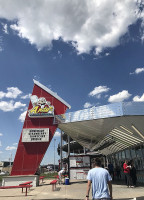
[{"left": 58, "top": 102, "right": 144, "bottom": 155}]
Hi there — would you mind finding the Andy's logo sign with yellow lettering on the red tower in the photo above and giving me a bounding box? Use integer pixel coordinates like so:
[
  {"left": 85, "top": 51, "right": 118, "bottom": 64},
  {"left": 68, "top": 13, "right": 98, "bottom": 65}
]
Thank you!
[{"left": 29, "top": 95, "right": 54, "bottom": 117}]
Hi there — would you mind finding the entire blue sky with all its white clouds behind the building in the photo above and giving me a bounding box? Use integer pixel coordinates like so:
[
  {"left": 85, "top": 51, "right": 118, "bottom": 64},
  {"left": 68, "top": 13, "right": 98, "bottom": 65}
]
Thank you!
[{"left": 0, "top": 0, "right": 144, "bottom": 164}]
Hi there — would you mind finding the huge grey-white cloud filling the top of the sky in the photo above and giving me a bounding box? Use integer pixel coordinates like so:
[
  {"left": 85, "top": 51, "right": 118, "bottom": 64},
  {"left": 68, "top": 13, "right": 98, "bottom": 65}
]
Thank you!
[{"left": 0, "top": 0, "right": 143, "bottom": 54}]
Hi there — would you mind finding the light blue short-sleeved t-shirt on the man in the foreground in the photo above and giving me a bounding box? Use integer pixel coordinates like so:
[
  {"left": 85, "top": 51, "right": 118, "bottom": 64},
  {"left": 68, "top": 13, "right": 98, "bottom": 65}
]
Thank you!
[{"left": 87, "top": 167, "right": 112, "bottom": 199}]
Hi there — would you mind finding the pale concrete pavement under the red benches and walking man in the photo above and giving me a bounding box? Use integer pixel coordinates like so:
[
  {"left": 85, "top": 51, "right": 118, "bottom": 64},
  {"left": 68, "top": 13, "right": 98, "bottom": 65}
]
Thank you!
[{"left": 0, "top": 180, "right": 144, "bottom": 200}]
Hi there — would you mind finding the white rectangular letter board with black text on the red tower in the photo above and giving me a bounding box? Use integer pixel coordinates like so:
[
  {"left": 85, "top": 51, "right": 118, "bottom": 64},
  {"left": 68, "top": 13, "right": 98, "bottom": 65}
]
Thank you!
[{"left": 22, "top": 128, "right": 49, "bottom": 142}]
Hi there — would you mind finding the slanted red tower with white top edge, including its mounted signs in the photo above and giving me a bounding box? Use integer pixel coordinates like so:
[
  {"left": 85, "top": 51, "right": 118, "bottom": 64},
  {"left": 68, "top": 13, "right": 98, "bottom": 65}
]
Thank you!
[{"left": 11, "top": 80, "right": 70, "bottom": 176}]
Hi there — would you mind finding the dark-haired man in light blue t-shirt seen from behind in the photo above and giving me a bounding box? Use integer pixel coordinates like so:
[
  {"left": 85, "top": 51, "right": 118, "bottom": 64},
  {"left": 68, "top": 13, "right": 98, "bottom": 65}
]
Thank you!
[{"left": 86, "top": 158, "right": 112, "bottom": 200}]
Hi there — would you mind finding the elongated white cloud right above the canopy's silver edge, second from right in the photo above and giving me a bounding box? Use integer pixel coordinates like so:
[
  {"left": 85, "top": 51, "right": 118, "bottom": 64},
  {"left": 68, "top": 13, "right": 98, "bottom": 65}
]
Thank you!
[{"left": 108, "top": 90, "right": 131, "bottom": 102}]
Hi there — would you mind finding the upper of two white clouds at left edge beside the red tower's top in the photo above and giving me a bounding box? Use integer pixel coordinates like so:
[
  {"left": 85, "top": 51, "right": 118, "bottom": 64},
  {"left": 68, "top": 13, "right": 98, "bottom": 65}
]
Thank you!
[{"left": 0, "top": 87, "right": 22, "bottom": 99}]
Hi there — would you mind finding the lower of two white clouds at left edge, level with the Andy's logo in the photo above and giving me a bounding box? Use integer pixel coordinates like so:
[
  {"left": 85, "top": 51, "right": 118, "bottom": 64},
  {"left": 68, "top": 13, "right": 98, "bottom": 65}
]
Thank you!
[{"left": 0, "top": 101, "right": 26, "bottom": 112}]
